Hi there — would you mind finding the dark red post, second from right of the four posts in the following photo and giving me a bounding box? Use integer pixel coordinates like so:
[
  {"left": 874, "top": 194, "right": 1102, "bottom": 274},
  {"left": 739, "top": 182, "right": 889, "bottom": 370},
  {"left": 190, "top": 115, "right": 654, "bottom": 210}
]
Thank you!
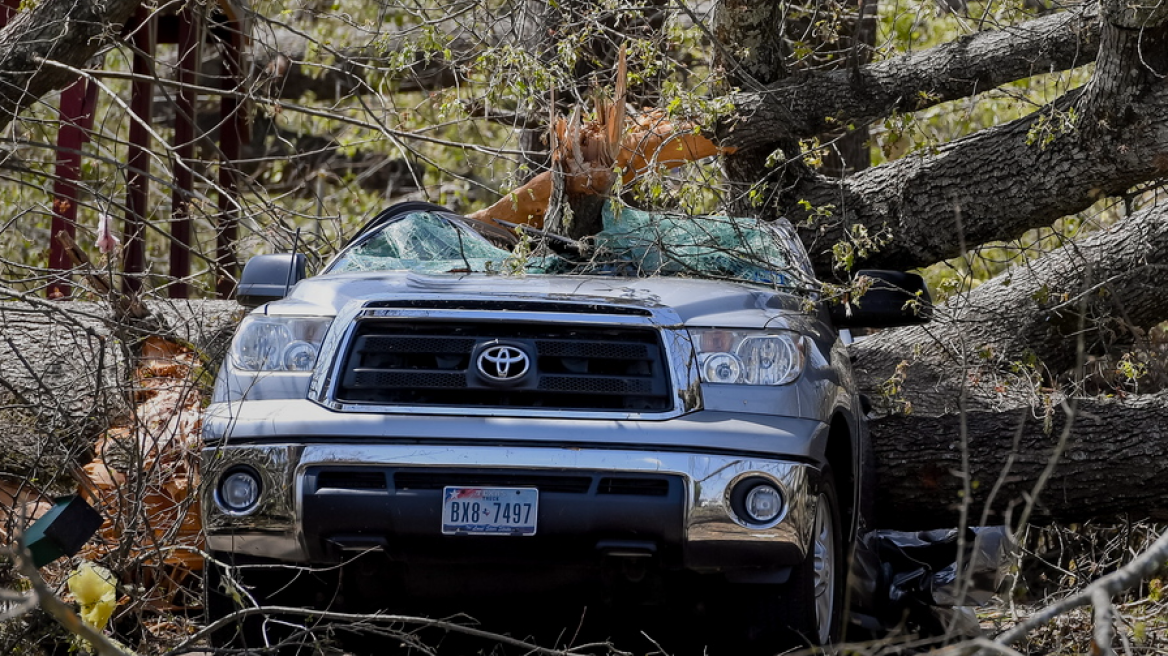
[{"left": 169, "top": 4, "right": 206, "bottom": 299}]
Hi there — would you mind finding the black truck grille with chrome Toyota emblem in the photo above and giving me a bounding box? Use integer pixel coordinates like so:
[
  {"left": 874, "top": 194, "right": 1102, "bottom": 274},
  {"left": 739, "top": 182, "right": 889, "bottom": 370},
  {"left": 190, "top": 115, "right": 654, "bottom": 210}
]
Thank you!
[{"left": 335, "top": 320, "right": 674, "bottom": 412}]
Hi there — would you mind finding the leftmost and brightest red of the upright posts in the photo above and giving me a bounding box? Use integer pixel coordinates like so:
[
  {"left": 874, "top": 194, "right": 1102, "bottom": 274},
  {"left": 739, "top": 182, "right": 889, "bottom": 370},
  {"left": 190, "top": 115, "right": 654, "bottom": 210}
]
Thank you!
[{"left": 47, "top": 79, "right": 96, "bottom": 299}]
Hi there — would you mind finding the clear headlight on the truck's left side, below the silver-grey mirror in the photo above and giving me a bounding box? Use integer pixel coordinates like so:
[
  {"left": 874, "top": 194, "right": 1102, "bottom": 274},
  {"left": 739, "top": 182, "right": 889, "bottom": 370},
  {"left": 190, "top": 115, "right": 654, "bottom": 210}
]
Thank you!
[{"left": 231, "top": 314, "right": 332, "bottom": 371}]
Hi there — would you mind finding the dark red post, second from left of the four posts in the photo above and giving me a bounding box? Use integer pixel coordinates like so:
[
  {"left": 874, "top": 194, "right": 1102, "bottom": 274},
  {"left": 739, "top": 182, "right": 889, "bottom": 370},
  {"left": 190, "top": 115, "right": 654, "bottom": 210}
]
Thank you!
[{"left": 121, "top": 8, "right": 157, "bottom": 294}]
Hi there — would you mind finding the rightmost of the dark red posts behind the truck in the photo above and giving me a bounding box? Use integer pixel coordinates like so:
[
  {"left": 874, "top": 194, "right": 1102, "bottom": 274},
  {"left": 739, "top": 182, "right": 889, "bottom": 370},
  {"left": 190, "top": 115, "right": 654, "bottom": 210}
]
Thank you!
[{"left": 215, "top": 24, "right": 246, "bottom": 299}]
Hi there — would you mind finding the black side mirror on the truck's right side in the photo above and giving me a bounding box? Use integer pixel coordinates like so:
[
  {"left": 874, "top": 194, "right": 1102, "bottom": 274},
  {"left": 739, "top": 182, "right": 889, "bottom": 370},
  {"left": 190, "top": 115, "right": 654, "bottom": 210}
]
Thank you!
[{"left": 832, "top": 270, "right": 933, "bottom": 328}]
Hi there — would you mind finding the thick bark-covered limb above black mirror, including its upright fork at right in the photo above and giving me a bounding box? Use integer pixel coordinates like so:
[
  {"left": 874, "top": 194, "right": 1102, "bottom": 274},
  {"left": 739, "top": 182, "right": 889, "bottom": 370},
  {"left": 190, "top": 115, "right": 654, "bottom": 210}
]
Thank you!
[{"left": 785, "top": 12, "right": 1168, "bottom": 272}]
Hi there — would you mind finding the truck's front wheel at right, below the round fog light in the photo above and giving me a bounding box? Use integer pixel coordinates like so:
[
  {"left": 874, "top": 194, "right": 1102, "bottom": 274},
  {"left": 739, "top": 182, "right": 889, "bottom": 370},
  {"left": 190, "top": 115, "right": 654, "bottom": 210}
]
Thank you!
[{"left": 779, "top": 467, "right": 848, "bottom": 645}]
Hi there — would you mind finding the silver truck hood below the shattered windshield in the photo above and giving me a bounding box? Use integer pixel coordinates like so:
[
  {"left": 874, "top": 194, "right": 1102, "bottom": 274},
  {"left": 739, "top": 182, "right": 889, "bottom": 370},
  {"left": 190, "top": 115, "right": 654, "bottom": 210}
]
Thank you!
[{"left": 267, "top": 272, "right": 813, "bottom": 328}]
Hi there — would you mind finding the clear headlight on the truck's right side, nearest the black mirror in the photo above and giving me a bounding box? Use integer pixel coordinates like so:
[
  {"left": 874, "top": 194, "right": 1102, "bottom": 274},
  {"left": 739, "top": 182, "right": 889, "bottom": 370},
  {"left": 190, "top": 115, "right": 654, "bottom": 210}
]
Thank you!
[{"left": 689, "top": 328, "right": 804, "bottom": 385}]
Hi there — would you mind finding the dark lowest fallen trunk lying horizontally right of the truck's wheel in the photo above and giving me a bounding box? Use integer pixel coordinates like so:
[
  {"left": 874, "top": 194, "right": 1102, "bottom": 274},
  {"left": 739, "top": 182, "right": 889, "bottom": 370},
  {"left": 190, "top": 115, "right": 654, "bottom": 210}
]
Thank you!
[{"left": 871, "top": 393, "right": 1168, "bottom": 530}]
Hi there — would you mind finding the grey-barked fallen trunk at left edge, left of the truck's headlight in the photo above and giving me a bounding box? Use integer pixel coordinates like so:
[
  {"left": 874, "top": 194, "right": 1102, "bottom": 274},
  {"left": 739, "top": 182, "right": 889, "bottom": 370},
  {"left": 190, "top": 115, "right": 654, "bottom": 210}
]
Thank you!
[{"left": 0, "top": 296, "right": 242, "bottom": 489}]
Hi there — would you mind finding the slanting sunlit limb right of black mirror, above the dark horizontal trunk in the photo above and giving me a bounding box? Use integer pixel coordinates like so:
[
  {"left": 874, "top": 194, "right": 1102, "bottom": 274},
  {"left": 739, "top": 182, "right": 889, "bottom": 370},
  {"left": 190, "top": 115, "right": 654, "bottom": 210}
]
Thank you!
[{"left": 853, "top": 201, "right": 1168, "bottom": 416}]
